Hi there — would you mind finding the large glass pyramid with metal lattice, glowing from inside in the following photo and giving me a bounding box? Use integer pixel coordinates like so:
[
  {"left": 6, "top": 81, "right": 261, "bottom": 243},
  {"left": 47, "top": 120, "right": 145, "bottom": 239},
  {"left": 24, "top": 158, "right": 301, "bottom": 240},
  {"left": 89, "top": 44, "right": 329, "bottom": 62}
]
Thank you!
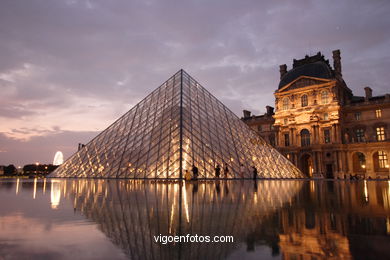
[{"left": 50, "top": 70, "right": 303, "bottom": 179}]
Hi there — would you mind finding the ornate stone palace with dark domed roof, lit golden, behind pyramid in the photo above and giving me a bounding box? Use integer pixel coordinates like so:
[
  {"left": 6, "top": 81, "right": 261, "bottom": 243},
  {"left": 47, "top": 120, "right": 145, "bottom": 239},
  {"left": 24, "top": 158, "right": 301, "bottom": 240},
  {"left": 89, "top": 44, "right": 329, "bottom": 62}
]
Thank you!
[{"left": 242, "top": 50, "right": 390, "bottom": 179}]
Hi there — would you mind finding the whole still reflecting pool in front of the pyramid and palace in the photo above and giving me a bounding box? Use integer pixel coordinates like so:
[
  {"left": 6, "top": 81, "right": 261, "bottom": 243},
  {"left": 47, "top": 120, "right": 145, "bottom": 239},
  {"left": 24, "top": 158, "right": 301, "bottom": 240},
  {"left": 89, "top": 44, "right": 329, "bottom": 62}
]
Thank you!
[{"left": 0, "top": 179, "right": 390, "bottom": 259}]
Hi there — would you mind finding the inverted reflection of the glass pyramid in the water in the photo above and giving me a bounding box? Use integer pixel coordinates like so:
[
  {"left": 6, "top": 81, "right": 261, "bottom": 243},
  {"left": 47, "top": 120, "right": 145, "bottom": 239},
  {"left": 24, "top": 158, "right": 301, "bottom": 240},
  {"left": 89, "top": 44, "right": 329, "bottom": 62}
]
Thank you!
[{"left": 63, "top": 180, "right": 303, "bottom": 259}]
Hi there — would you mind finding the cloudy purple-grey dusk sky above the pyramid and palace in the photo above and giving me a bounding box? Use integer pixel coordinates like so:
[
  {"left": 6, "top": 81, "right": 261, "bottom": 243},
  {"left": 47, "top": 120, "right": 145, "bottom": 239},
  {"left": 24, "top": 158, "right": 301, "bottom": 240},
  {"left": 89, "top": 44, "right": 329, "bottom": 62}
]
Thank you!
[{"left": 0, "top": 0, "right": 390, "bottom": 166}]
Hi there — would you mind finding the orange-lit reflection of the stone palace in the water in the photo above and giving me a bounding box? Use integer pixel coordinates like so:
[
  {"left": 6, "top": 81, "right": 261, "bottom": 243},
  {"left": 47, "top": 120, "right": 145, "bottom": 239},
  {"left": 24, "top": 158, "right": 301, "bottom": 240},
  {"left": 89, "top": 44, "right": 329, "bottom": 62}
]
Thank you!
[{"left": 279, "top": 182, "right": 390, "bottom": 259}]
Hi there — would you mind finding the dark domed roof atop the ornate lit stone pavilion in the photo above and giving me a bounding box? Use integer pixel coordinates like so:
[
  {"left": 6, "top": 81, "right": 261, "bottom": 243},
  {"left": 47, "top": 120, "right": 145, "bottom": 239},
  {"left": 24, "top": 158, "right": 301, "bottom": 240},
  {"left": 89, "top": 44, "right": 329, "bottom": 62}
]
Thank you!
[{"left": 278, "top": 57, "right": 334, "bottom": 89}]
